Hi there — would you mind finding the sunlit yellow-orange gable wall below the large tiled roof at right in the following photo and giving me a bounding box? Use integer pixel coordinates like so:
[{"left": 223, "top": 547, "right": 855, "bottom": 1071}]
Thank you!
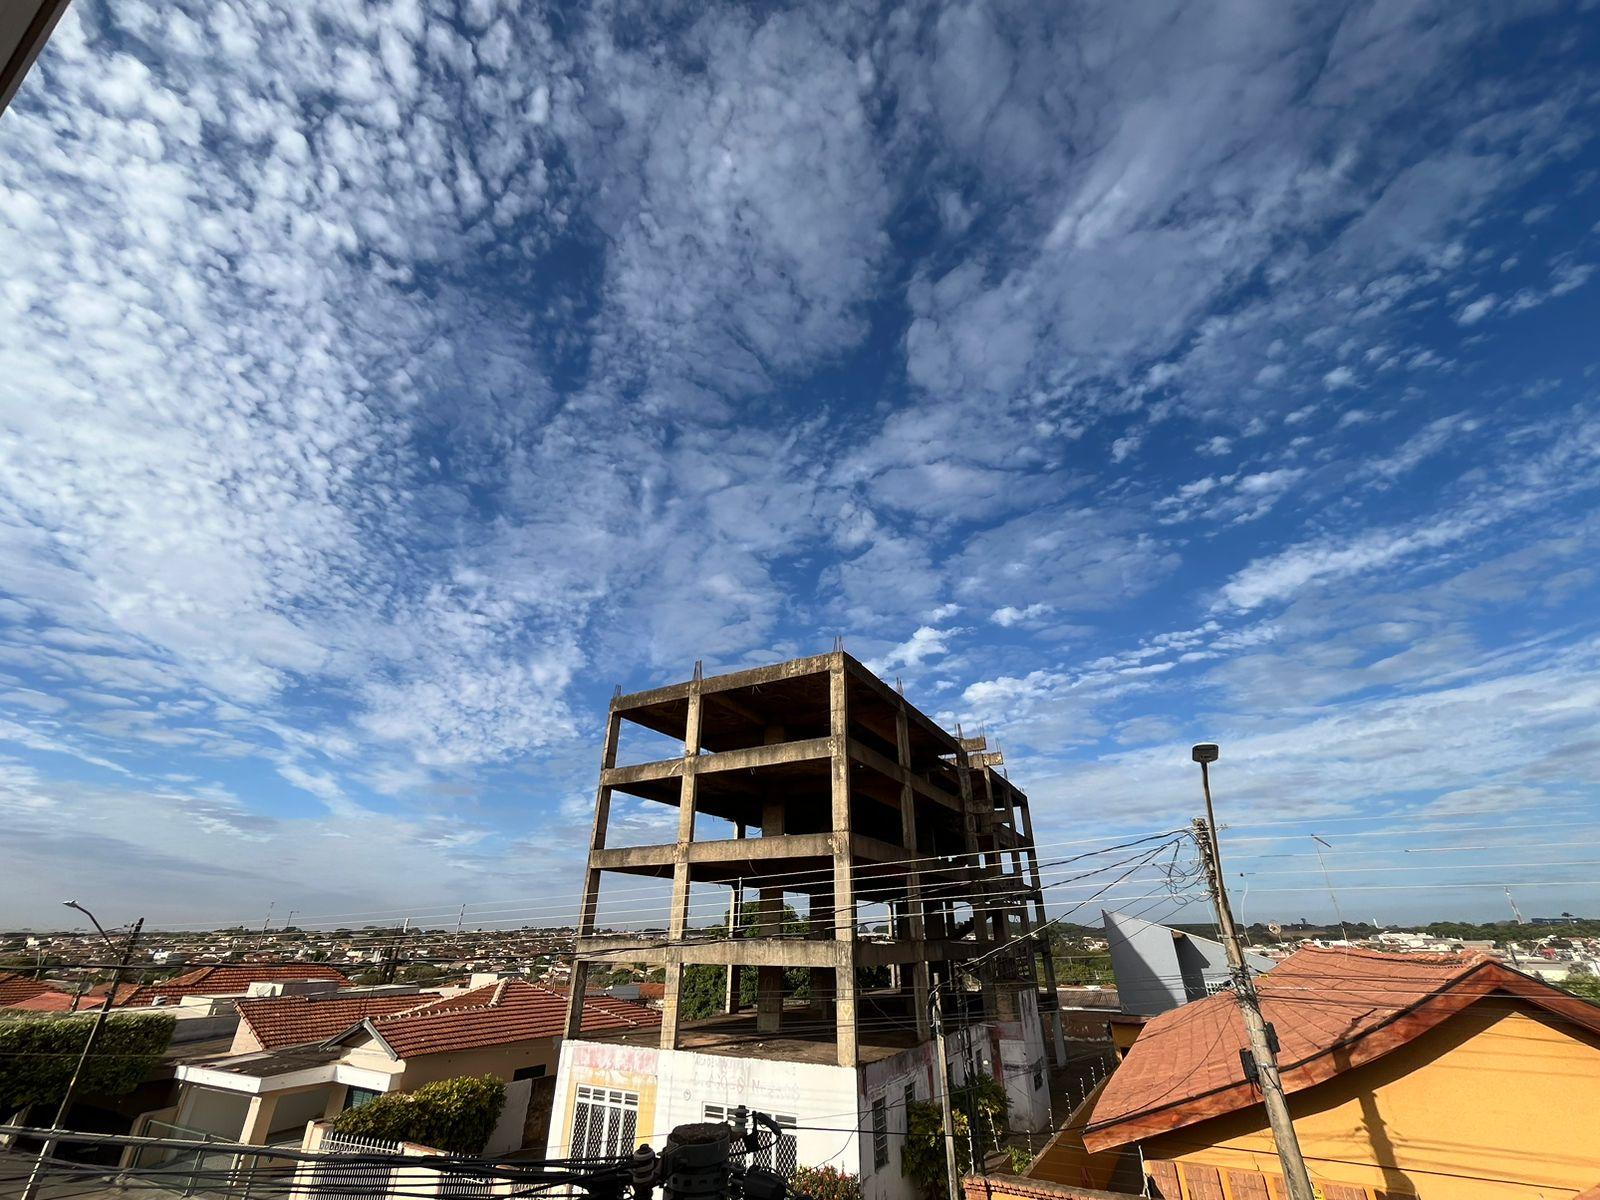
[{"left": 1142, "top": 998, "right": 1600, "bottom": 1200}]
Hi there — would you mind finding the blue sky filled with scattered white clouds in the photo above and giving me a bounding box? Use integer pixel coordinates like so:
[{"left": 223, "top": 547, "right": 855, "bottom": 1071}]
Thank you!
[{"left": 0, "top": 0, "right": 1600, "bottom": 922}]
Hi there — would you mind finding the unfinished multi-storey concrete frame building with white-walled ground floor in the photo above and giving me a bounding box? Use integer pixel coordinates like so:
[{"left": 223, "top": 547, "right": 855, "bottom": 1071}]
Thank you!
[{"left": 550, "top": 651, "right": 1061, "bottom": 1200}]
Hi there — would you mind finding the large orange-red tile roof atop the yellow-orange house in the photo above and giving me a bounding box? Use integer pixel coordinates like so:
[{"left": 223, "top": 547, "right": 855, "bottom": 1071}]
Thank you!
[{"left": 1083, "top": 947, "right": 1600, "bottom": 1150}]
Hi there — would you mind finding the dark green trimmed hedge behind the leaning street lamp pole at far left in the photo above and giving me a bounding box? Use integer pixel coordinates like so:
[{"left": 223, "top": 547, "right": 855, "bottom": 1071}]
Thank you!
[{"left": 0, "top": 1013, "right": 178, "bottom": 1112}]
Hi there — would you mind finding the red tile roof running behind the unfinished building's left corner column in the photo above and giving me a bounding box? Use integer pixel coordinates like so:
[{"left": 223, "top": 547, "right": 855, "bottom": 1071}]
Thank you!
[{"left": 338, "top": 979, "right": 661, "bottom": 1058}]
